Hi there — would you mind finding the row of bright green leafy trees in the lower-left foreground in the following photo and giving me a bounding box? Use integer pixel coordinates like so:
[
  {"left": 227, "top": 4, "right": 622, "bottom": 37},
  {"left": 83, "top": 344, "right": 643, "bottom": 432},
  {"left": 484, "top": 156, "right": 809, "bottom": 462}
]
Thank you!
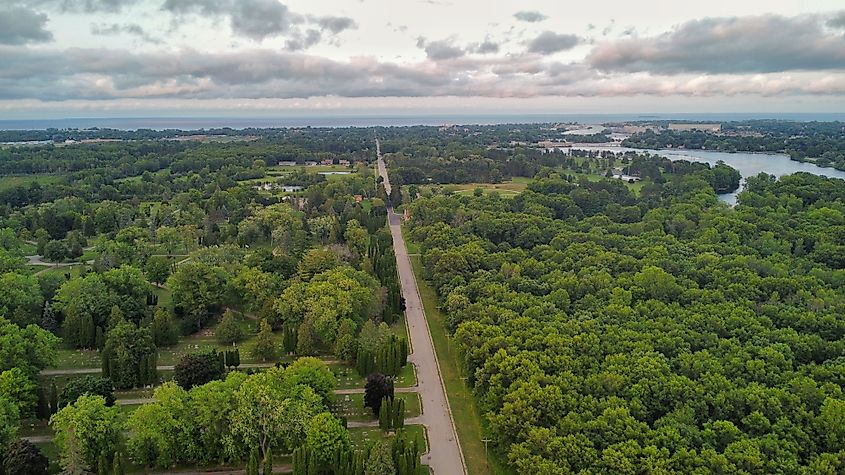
[{"left": 45, "top": 358, "right": 336, "bottom": 470}]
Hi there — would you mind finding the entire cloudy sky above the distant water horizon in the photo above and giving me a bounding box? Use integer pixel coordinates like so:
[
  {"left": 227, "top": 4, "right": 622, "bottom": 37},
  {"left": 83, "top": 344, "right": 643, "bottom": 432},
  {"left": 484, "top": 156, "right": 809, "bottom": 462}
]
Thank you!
[{"left": 0, "top": 0, "right": 845, "bottom": 119}]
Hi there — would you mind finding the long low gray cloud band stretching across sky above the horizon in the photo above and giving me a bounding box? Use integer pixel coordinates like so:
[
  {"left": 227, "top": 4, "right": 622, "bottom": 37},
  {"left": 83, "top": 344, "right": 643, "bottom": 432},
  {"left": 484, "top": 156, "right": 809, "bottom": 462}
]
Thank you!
[{"left": 0, "top": 47, "right": 845, "bottom": 101}]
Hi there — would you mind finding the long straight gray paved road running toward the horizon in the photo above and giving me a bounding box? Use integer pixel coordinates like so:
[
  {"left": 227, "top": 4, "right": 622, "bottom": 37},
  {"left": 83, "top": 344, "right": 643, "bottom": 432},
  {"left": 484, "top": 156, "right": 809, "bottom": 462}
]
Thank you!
[{"left": 376, "top": 139, "right": 467, "bottom": 475}]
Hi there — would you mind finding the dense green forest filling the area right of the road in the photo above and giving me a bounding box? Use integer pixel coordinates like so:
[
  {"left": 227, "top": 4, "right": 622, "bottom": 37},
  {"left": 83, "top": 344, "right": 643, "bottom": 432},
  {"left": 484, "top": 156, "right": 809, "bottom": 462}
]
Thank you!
[{"left": 407, "top": 174, "right": 845, "bottom": 475}]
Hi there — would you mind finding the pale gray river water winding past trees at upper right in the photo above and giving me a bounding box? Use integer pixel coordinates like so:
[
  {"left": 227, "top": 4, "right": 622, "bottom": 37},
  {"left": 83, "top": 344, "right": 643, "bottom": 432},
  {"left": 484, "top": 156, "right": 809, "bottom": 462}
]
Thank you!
[{"left": 573, "top": 145, "right": 845, "bottom": 206}]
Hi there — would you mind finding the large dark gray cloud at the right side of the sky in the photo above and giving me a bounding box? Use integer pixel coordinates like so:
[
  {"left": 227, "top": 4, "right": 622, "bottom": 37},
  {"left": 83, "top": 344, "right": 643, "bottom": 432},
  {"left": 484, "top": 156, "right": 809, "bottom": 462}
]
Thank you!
[{"left": 587, "top": 15, "right": 845, "bottom": 74}]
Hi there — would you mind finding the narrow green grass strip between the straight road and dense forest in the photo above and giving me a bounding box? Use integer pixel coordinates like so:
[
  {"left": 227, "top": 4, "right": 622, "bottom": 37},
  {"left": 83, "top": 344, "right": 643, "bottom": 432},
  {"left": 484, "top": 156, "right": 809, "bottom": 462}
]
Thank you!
[{"left": 403, "top": 255, "right": 512, "bottom": 475}]
